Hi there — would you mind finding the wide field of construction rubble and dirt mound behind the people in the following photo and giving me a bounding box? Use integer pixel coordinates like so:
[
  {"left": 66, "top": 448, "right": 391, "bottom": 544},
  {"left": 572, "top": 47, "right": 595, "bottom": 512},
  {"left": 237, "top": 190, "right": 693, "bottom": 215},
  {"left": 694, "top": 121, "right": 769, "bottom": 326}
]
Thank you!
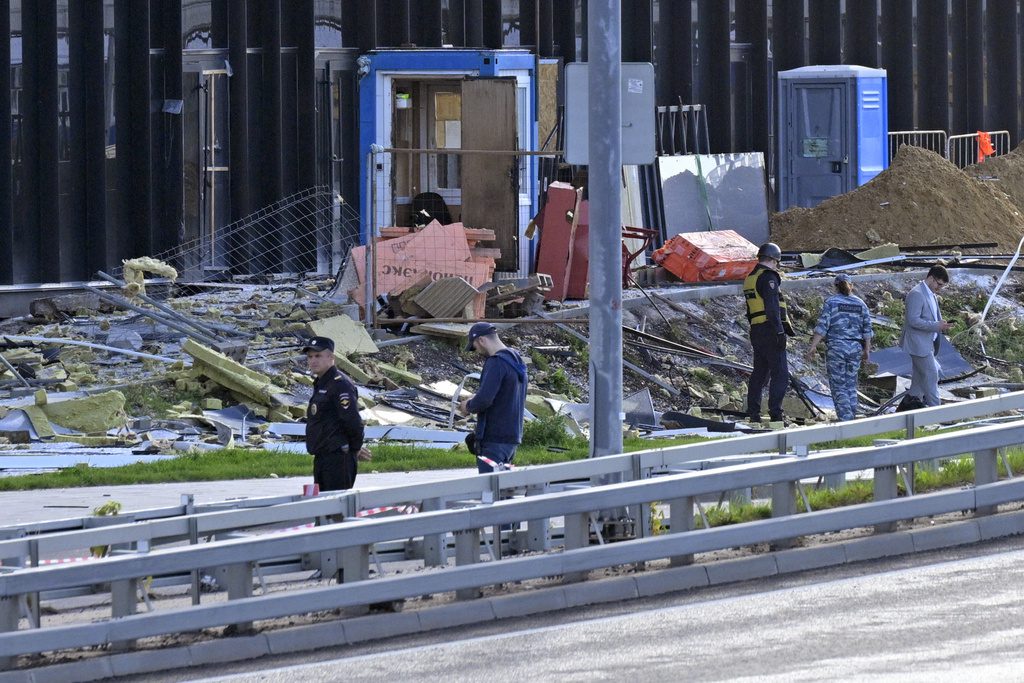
[{"left": 6, "top": 142, "right": 1024, "bottom": 473}]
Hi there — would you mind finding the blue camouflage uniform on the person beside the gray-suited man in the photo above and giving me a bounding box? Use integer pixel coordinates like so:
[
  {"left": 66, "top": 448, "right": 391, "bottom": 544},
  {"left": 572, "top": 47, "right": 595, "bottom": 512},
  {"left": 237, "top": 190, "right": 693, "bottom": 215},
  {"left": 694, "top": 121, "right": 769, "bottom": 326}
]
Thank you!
[{"left": 814, "top": 294, "right": 873, "bottom": 420}]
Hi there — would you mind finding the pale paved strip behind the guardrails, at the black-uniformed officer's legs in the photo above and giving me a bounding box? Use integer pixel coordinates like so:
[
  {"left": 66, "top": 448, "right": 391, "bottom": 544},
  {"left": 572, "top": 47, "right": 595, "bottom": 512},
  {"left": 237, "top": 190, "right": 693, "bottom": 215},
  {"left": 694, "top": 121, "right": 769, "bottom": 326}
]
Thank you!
[{"left": 0, "top": 469, "right": 476, "bottom": 526}]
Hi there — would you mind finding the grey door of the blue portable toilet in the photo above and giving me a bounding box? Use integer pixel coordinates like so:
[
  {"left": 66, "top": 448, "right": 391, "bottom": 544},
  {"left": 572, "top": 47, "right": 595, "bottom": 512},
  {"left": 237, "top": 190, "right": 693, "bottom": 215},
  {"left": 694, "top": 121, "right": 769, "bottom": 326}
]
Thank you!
[{"left": 785, "top": 82, "right": 852, "bottom": 208}]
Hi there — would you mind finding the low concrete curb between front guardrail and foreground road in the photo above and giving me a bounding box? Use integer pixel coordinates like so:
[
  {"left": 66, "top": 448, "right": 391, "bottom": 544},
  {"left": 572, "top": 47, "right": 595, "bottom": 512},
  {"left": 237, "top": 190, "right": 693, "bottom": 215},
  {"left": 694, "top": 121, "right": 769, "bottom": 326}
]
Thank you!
[{"left": 8, "top": 510, "right": 1024, "bottom": 683}]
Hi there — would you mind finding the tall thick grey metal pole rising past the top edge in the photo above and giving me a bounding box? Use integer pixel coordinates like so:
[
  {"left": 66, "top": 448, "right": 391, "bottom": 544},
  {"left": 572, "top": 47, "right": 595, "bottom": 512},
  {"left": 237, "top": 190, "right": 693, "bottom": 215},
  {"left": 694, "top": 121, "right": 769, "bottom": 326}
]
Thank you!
[{"left": 587, "top": 0, "right": 623, "bottom": 458}]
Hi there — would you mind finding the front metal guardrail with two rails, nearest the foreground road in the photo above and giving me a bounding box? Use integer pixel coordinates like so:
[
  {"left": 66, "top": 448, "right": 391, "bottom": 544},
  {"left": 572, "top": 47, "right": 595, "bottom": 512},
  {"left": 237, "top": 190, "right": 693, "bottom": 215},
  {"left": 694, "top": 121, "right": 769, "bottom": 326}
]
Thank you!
[{"left": 0, "top": 399, "right": 1024, "bottom": 666}]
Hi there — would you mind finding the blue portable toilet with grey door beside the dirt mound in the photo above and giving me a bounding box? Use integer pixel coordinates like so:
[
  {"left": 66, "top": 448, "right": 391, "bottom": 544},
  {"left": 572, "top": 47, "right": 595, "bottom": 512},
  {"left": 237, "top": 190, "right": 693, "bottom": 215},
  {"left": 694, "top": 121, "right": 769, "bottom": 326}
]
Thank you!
[{"left": 776, "top": 65, "right": 889, "bottom": 211}]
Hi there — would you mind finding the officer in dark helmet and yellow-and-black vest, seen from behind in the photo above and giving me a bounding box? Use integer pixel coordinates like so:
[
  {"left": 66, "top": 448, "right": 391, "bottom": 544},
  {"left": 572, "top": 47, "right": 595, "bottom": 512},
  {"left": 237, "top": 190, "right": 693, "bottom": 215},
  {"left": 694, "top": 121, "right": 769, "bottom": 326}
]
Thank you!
[{"left": 743, "top": 242, "right": 795, "bottom": 422}]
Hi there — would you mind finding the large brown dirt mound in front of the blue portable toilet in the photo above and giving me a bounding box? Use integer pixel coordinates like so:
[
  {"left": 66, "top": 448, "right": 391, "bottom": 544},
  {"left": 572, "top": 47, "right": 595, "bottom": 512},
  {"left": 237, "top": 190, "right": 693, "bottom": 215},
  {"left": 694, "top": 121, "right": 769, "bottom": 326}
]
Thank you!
[{"left": 771, "top": 145, "right": 1024, "bottom": 252}]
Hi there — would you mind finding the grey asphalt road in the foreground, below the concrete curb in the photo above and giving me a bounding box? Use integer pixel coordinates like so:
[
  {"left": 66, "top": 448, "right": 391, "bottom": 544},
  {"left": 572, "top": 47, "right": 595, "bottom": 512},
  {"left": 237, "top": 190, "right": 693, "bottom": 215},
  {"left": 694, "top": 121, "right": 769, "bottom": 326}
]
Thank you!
[{"left": 145, "top": 539, "right": 1024, "bottom": 683}]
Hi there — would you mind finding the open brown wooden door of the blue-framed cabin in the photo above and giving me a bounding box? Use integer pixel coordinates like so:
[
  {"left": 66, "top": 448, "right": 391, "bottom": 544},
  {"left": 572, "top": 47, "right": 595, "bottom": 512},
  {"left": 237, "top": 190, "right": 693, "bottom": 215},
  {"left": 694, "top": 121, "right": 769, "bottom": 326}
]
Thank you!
[{"left": 462, "top": 77, "right": 519, "bottom": 271}]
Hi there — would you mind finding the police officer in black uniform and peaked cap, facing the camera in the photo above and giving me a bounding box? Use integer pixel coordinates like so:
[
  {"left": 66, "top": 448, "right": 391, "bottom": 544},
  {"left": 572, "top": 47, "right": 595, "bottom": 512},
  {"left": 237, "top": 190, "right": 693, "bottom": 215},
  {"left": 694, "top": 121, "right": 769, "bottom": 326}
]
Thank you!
[{"left": 302, "top": 337, "right": 362, "bottom": 492}]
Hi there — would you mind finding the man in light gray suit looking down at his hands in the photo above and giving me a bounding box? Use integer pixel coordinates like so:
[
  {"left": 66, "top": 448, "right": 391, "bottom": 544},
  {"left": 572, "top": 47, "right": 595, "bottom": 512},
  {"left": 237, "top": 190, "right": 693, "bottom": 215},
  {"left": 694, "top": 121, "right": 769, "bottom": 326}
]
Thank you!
[{"left": 900, "top": 265, "right": 952, "bottom": 405}]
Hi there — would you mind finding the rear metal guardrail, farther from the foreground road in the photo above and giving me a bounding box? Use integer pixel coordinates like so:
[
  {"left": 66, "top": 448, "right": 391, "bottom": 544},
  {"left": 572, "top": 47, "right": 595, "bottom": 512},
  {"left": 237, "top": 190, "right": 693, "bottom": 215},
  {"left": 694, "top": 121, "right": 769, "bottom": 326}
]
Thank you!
[{"left": 6, "top": 391, "right": 1024, "bottom": 565}]
